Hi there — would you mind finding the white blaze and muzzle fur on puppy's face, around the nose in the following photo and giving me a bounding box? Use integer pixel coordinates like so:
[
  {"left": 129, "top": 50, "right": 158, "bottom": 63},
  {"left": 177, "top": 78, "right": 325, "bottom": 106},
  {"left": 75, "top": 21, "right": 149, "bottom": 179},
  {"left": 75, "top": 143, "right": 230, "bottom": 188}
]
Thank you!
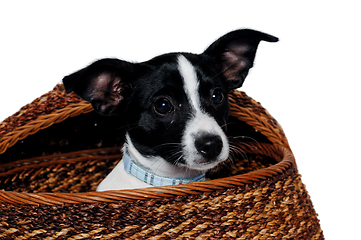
[{"left": 178, "top": 55, "right": 229, "bottom": 171}]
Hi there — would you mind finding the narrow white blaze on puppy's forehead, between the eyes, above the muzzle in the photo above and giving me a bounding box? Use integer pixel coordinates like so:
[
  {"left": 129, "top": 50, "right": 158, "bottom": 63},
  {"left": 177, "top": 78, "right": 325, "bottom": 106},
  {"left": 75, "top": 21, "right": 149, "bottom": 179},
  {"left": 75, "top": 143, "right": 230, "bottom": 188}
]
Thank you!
[{"left": 178, "top": 55, "right": 201, "bottom": 111}]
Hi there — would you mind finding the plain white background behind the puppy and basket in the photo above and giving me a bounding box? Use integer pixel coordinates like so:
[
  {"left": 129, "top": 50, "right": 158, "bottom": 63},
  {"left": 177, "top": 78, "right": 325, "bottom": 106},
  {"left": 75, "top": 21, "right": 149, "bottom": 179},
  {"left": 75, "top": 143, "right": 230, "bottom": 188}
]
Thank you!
[{"left": 0, "top": 0, "right": 361, "bottom": 239}]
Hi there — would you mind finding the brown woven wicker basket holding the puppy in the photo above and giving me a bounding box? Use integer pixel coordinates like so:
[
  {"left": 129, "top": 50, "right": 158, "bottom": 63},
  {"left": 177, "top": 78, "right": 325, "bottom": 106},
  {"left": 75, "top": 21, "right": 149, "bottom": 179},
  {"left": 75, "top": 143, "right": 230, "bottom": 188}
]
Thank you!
[{"left": 0, "top": 85, "right": 324, "bottom": 239}]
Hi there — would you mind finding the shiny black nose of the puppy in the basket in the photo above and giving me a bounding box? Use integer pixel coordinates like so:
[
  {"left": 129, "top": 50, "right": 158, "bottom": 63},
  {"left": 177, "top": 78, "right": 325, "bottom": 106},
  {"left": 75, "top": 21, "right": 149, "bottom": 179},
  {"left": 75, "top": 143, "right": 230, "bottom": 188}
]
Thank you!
[{"left": 195, "top": 135, "right": 223, "bottom": 161}]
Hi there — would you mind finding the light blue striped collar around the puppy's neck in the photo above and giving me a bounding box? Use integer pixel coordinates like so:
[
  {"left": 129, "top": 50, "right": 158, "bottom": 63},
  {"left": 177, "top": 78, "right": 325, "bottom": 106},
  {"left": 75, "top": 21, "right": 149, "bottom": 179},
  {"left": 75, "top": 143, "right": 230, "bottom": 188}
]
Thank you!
[{"left": 123, "top": 153, "right": 206, "bottom": 187}]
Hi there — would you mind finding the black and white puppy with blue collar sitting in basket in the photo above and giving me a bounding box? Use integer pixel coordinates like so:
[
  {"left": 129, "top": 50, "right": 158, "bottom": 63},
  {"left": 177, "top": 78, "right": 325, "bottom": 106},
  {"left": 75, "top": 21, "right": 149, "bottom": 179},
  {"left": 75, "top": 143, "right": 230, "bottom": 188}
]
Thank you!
[{"left": 63, "top": 29, "right": 278, "bottom": 191}]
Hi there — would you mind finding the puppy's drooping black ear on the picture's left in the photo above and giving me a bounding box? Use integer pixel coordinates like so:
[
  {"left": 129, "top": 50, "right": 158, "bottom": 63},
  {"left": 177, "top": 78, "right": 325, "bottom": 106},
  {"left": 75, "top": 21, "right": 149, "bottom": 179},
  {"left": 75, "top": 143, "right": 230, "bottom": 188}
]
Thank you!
[{"left": 63, "top": 58, "right": 134, "bottom": 115}]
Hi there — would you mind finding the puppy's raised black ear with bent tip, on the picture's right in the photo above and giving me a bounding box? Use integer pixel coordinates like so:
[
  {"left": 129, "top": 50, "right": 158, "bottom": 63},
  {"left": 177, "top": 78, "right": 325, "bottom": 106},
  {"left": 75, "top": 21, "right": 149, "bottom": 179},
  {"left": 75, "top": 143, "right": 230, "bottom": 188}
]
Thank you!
[{"left": 204, "top": 29, "right": 278, "bottom": 90}]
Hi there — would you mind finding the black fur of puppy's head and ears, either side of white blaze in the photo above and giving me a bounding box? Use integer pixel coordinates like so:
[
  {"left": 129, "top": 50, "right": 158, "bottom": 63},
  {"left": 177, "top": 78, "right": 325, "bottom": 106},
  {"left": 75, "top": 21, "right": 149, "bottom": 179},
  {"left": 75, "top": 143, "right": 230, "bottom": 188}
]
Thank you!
[{"left": 63, "top": 30, "right": 278, "bottom": 163}]
